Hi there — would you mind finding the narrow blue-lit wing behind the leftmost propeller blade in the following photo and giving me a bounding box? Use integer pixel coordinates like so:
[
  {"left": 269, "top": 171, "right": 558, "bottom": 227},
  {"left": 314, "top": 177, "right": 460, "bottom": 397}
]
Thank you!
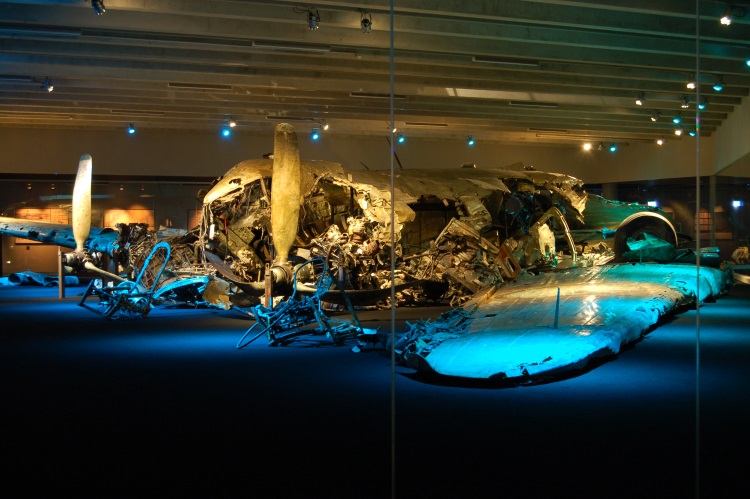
[{"left": 0, "top": 217, "right": 117, "bottom": 252}]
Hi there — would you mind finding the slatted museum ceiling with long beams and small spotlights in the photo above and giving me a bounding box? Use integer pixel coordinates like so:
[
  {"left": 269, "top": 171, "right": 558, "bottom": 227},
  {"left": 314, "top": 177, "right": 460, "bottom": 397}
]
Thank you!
[{"left": 0, "top": 0, "right": 750, "bottom": 145}]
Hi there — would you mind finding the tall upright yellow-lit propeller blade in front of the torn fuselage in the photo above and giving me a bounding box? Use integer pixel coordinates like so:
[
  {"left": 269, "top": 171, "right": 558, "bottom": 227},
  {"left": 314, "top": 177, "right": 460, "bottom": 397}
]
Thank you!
[{"left": 271, "top": 123, "right": 301, "bottom": 264}]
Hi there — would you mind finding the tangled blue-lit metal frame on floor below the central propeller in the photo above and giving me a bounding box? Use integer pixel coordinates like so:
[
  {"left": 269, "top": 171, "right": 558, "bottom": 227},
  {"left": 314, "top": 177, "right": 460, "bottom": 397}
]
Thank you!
[{"left": 237, "top": 258, "right": 377, "bottom": 349}]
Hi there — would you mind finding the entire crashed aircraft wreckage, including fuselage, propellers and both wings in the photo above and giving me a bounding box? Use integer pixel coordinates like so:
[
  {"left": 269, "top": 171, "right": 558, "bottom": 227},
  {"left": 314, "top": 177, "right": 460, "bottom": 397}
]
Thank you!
[{"left": 0, "top": 124, "right": 727, "bottom": 378}]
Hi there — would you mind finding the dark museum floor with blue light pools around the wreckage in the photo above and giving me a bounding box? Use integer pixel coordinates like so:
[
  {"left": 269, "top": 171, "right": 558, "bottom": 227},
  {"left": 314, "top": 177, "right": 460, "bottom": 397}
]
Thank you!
[{"left": 0, "top": 286, "right": 750, "bottom": 498}]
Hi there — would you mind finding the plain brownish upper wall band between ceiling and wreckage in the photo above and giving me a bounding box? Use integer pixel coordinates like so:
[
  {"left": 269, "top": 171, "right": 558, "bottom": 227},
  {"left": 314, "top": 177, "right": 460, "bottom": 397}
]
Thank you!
[{"left": 0, "top": 127, "right": 728, "bottom": 183}]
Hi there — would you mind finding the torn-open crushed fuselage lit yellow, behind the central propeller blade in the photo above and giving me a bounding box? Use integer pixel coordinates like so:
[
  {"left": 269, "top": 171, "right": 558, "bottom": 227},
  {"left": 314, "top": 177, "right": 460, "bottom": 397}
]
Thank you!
[{"left": 200, "top": 159, "right": 586, "bottom": 302}]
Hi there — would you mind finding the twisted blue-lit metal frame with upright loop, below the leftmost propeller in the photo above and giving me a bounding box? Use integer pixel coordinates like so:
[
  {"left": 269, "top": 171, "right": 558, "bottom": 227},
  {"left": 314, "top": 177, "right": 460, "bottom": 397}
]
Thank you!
[{"left": 78, "top": 241, "right": 176, "bottom": 319}]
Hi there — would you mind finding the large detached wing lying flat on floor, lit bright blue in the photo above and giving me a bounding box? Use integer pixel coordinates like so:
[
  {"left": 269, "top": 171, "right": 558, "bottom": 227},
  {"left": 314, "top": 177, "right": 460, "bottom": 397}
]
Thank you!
[{"left": 396, "top": 264, "right": 730, "bottom": 382}]
